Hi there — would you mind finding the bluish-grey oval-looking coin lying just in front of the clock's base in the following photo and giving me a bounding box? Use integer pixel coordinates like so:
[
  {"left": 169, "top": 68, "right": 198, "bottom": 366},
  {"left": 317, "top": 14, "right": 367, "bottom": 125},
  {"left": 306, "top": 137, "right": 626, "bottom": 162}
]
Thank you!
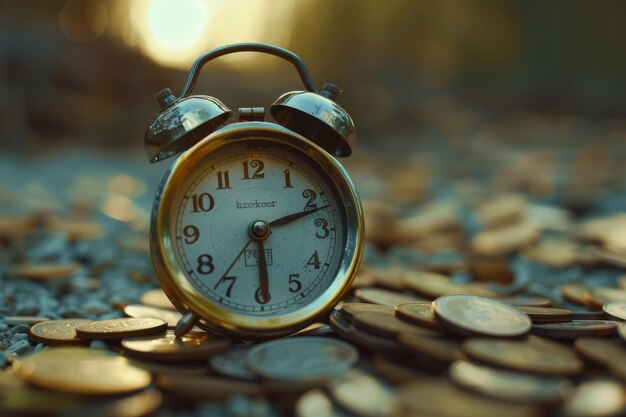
[{"left": 247, "top": 336, "right": 359, "bottom": 382}]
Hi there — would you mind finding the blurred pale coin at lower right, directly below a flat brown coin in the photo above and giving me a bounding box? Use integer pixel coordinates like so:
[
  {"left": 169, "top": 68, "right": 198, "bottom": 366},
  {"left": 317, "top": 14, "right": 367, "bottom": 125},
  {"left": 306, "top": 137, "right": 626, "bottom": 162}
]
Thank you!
[{"left": 448, "top": 360, "right": 571, "bottom": 404}]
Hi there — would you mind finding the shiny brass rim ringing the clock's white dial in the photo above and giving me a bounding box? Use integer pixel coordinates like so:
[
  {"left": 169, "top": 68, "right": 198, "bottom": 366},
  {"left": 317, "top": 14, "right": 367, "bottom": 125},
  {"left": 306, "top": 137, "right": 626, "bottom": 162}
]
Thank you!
[{"left": 150, "top": 122, "right": 364, "bottom": 338}]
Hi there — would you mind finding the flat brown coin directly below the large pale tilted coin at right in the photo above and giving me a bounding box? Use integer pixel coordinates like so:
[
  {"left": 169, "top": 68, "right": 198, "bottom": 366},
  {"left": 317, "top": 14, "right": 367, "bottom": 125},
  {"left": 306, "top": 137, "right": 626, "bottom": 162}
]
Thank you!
[{"left": 461, "top": 337, "right": 583, "bottom": 376}]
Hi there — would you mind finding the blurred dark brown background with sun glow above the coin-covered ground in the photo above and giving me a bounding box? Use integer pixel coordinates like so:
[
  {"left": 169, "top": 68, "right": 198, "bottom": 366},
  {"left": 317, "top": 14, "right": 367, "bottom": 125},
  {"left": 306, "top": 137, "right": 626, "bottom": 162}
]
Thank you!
[{"left": 0, "top": 0, "right": 626, "bottom": 214}]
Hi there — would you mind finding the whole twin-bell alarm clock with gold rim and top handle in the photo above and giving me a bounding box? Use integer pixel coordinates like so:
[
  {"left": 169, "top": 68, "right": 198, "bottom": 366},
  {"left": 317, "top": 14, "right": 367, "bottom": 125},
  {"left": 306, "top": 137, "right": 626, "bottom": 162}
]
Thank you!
[{"left": 145, "top": 43, "right": 364, "bottom": 339}]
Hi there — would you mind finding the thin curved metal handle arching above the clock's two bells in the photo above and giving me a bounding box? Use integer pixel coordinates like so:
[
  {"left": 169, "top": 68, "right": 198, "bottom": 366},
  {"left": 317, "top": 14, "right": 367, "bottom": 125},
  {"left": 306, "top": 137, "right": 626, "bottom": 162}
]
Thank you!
[{"left": 179, "top": 42, "right": 317, "bottom": 98}]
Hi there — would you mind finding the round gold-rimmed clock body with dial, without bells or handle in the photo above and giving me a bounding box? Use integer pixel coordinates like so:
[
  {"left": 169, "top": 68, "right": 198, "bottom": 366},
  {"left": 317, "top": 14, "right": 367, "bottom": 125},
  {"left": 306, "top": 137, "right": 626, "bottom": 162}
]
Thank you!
[{"left": 151, "top": 122, "right": 363, "bottom": 337}]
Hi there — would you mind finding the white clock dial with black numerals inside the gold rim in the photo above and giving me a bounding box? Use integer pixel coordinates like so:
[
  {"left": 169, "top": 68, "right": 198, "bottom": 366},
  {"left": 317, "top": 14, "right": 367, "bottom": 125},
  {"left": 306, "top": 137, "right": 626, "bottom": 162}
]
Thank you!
[{"left": 170, "top": 139, "right": 346, "bottom": 316}]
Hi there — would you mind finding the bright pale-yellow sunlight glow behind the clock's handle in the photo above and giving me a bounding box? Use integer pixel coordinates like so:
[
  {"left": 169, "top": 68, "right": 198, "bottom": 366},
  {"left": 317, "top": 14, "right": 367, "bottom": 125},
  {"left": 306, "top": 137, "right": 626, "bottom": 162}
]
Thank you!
[{"left": 122, "top": 0, "right": 296, "bottom": 68}]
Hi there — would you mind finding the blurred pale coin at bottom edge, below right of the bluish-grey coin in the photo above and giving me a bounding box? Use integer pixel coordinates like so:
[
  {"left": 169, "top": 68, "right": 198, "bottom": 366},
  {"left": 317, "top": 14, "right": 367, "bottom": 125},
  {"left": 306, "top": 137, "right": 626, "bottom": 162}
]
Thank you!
[{"left": 328, "top": 369, "right": 395, "bottom": 417}]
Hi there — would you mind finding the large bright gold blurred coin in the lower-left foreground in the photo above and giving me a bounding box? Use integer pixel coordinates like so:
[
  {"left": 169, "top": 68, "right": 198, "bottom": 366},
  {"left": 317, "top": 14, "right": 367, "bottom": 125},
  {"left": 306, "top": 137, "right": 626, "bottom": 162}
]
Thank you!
[{"left": 13, "top": 347, "right": 151, "bottom": 395}]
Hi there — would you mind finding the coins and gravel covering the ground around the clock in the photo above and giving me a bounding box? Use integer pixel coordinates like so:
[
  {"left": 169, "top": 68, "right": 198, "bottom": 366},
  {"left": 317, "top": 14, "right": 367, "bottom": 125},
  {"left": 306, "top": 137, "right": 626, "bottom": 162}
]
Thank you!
[{"left": 0, "top": 125, "right": 626, "bottom": 417}]
